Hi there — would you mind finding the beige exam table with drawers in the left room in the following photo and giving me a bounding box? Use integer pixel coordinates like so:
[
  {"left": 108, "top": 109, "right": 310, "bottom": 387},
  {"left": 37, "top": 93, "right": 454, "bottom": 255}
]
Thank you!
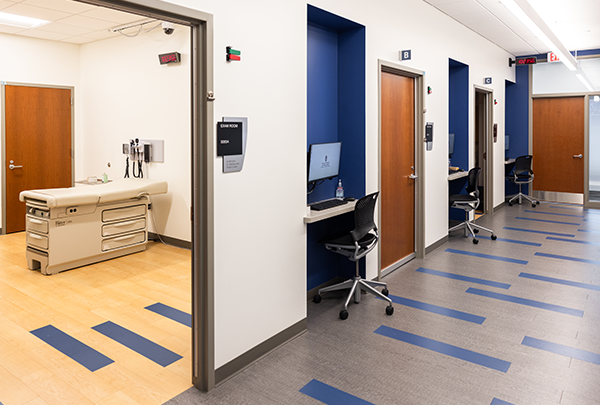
[{"left": 19, "top": 179, "right": 168, "bottom": 275}]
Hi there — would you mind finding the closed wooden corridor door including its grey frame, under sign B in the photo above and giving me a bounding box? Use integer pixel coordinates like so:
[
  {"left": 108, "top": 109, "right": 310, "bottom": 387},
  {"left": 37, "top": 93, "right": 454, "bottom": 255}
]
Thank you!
[{"left": 379, "top": 61, "right": 424, "bottom": 275}]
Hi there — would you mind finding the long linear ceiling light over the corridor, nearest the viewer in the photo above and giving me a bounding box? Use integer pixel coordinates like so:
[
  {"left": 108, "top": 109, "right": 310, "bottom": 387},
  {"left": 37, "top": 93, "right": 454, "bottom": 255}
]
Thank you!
[{"left": 500, "top": 0, "right": 577, "bottom": 70}]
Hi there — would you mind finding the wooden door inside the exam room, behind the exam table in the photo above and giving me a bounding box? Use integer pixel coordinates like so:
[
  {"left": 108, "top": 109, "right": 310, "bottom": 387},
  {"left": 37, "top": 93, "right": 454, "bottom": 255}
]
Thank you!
[{"left": 4, "top": 85, "right": 72, "bottom": 233}]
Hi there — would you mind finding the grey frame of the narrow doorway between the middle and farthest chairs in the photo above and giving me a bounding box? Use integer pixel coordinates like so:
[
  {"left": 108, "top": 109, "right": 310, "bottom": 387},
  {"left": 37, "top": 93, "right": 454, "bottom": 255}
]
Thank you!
[{"left": 473, "top": 84, "right": 494, "bottom": 214}]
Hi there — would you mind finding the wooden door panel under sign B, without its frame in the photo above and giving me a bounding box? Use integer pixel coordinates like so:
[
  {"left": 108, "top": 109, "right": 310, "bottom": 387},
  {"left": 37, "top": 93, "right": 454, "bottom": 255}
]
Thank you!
[{"left": 380, "top": 72, "right": 415, "bottom": 269}]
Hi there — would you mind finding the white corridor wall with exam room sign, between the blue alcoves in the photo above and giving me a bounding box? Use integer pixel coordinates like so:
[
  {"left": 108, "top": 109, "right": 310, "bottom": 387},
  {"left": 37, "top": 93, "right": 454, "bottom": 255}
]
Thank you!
[{"left": 164, "top": 0, "right": 514, "bottom": 367}]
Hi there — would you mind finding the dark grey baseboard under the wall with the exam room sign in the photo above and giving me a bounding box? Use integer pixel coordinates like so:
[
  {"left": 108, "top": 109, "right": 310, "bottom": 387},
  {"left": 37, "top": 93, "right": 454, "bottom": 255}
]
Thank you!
[{"left": 215, "top": 318, "right": 307, "bottom": 385}]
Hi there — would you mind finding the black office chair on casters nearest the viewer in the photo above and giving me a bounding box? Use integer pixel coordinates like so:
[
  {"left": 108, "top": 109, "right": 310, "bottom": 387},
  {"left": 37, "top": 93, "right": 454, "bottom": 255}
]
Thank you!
[{"left": 313, "top": 191, "right": 394, "bottom": 319}]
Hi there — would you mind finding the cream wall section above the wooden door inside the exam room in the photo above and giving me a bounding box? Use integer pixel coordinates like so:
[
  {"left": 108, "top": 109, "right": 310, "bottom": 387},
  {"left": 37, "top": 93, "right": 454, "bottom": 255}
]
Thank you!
[{"left": 0, "top": 33, "right": 81, "bottom": 223}]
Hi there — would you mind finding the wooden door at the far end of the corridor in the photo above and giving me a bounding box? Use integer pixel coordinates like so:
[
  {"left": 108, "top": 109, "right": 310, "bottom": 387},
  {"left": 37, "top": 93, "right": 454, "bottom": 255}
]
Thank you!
[{"left": 533, "top": 97, "right": 585, "bottom": 194}]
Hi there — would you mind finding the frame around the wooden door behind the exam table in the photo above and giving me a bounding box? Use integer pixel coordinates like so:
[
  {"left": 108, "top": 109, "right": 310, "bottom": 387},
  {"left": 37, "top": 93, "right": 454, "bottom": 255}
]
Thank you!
[{"left": 0, "top": 81, "right": 75, "bottom": 235}]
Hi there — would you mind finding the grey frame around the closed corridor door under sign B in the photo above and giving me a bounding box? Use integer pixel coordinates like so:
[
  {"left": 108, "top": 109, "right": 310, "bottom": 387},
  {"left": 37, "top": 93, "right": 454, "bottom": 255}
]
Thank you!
[{"left": 377, "top": 59, "right": 425, "bottom": 279}]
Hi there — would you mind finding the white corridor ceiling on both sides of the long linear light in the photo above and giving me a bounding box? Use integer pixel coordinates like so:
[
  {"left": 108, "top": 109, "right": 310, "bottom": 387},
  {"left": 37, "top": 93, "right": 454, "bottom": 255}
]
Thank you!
[{"left": 424, "top": 0, "right": 600, "bottom": 56}]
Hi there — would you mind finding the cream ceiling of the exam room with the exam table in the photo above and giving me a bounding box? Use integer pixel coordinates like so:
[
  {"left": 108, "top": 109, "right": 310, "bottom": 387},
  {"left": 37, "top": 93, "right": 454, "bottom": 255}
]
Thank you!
[{"left": 0, "top": 0, "right": 158, "bottom": 44}]
